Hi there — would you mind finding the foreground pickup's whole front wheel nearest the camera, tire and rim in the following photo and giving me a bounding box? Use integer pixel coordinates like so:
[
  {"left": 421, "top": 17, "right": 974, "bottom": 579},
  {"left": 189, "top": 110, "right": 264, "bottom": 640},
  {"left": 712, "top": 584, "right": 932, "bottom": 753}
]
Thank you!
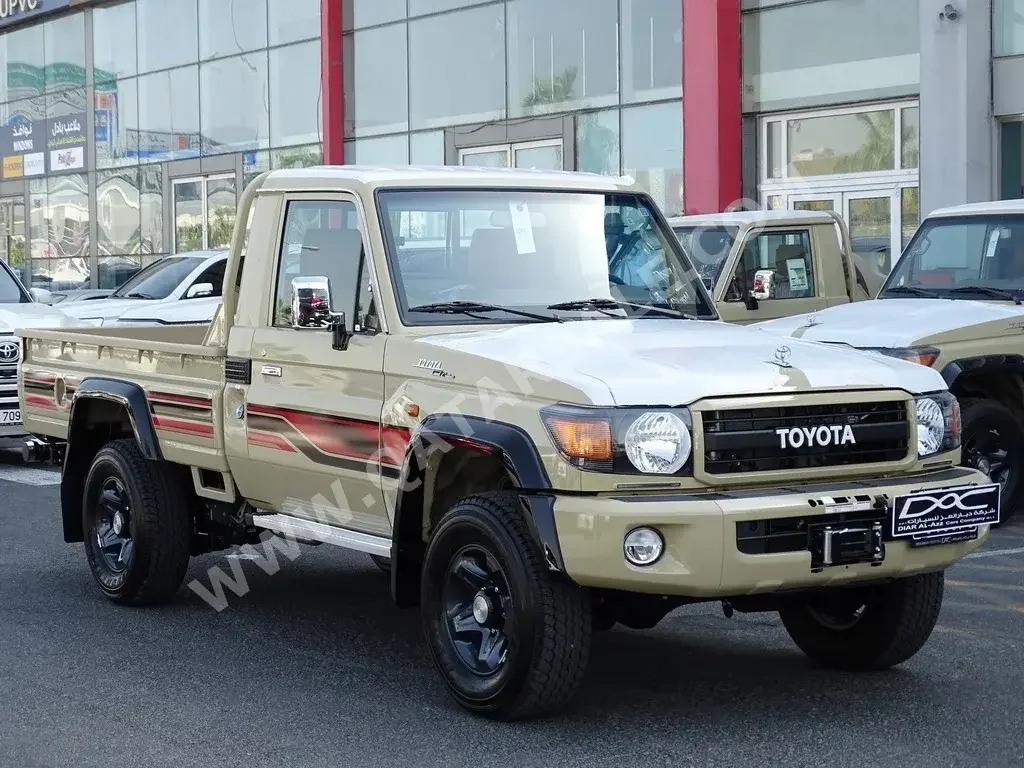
[{"left": 420, "top": 494, "right": 592, "bottom": 720}]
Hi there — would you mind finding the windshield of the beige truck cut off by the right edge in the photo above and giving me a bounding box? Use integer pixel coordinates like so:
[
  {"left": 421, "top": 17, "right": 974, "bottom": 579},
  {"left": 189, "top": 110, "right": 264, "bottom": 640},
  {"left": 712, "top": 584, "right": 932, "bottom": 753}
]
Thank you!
[{"left": 880, "top": 216, "right": 1024, "bottom": 298}]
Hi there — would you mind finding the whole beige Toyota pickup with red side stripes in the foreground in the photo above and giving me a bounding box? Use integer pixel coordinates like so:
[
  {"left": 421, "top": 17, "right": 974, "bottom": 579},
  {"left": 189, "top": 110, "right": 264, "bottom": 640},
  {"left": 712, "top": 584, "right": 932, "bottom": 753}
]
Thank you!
[{"left": 19, "top": 166, "right": 999, "bottom": 719}]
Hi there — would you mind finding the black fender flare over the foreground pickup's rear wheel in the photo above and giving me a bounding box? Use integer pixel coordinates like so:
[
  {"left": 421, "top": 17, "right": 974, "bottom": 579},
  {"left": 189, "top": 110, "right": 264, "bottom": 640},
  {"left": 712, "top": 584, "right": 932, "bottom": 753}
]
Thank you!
[{"left": 60, "top": 377, "right": 163, "bottom": 544}]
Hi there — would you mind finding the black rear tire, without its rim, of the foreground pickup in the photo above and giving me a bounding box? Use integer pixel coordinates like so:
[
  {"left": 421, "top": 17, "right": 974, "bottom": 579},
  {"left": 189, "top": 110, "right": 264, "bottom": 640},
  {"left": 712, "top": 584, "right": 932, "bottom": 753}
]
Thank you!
[{"left": 82, "top": 439, "right": 191, "bottom": 605}]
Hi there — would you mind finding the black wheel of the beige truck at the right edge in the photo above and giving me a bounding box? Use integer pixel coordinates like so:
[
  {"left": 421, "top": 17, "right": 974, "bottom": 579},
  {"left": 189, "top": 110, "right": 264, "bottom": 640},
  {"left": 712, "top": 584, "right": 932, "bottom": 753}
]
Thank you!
[{"left": 961, "top": 399, "right": 1024, "bottom": 520}]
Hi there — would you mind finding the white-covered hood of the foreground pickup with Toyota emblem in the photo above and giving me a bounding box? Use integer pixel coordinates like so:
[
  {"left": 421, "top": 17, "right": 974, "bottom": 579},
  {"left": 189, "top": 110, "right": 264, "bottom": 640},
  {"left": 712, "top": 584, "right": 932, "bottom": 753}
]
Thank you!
[{"left": 420, "top": 318, "right": 945, "bottom": 406}]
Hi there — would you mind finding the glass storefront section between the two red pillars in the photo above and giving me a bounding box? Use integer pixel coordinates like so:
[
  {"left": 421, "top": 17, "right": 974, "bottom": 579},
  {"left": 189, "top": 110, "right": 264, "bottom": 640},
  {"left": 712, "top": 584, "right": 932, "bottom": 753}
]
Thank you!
[{"left": 342, "top": 0, "right": 683, "bottom": 215}]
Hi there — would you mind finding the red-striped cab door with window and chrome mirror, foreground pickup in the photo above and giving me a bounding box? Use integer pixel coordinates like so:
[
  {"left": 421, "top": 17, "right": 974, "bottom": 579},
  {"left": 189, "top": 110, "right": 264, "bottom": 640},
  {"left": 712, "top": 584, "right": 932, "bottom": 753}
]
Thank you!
[{"left": 234, "top": 194, "right": 396, "bottom": 536}]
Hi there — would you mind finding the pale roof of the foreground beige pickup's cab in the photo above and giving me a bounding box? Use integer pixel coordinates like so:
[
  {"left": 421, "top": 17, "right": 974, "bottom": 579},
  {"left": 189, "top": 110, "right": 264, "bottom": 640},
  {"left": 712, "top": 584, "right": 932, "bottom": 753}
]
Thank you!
[{"left": 261, "top": 165, "right": 641, "bottom": 191}]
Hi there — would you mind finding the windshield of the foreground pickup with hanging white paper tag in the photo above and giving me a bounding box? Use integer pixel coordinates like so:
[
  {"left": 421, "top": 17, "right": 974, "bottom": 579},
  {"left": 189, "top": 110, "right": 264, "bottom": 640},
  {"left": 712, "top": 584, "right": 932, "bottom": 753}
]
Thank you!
[{"left": 378, "top": 189, "right": 715, "bottom": 325}]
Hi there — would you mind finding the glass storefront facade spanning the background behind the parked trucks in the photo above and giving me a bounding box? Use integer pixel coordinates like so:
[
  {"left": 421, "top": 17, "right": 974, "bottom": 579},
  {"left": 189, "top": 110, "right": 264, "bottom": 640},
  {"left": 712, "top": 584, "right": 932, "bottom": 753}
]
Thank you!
[{"left": 0, "top": 0, "right": 1007, "bottom": 288}]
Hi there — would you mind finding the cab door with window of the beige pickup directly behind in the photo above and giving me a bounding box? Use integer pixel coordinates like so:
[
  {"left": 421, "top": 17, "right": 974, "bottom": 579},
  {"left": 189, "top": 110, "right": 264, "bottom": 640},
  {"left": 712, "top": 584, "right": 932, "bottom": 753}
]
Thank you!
[{"left": 718, "top": 228, "right": 827, "bottom": 325}]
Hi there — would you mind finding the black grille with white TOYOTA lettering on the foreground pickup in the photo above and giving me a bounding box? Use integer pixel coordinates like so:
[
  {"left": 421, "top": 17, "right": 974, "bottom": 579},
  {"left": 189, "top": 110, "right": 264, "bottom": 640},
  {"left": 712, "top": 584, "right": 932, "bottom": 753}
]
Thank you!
[{"left": 702, "top": 400, "right": 910, "bottom": 474}]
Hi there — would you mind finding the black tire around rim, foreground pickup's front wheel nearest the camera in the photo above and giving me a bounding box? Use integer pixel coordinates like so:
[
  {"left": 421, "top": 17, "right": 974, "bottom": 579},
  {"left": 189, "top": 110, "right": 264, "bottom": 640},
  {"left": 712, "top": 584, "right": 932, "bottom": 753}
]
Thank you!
[{"left": 420, "top": 493, "right": 592, "bottom": 721}]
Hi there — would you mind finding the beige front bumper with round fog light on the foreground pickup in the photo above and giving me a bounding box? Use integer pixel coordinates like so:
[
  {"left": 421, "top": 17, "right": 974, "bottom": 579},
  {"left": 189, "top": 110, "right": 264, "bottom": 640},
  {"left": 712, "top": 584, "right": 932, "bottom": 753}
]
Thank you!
[{"left": 554, "top": 467, "right": 988, "bottom": 598}]
